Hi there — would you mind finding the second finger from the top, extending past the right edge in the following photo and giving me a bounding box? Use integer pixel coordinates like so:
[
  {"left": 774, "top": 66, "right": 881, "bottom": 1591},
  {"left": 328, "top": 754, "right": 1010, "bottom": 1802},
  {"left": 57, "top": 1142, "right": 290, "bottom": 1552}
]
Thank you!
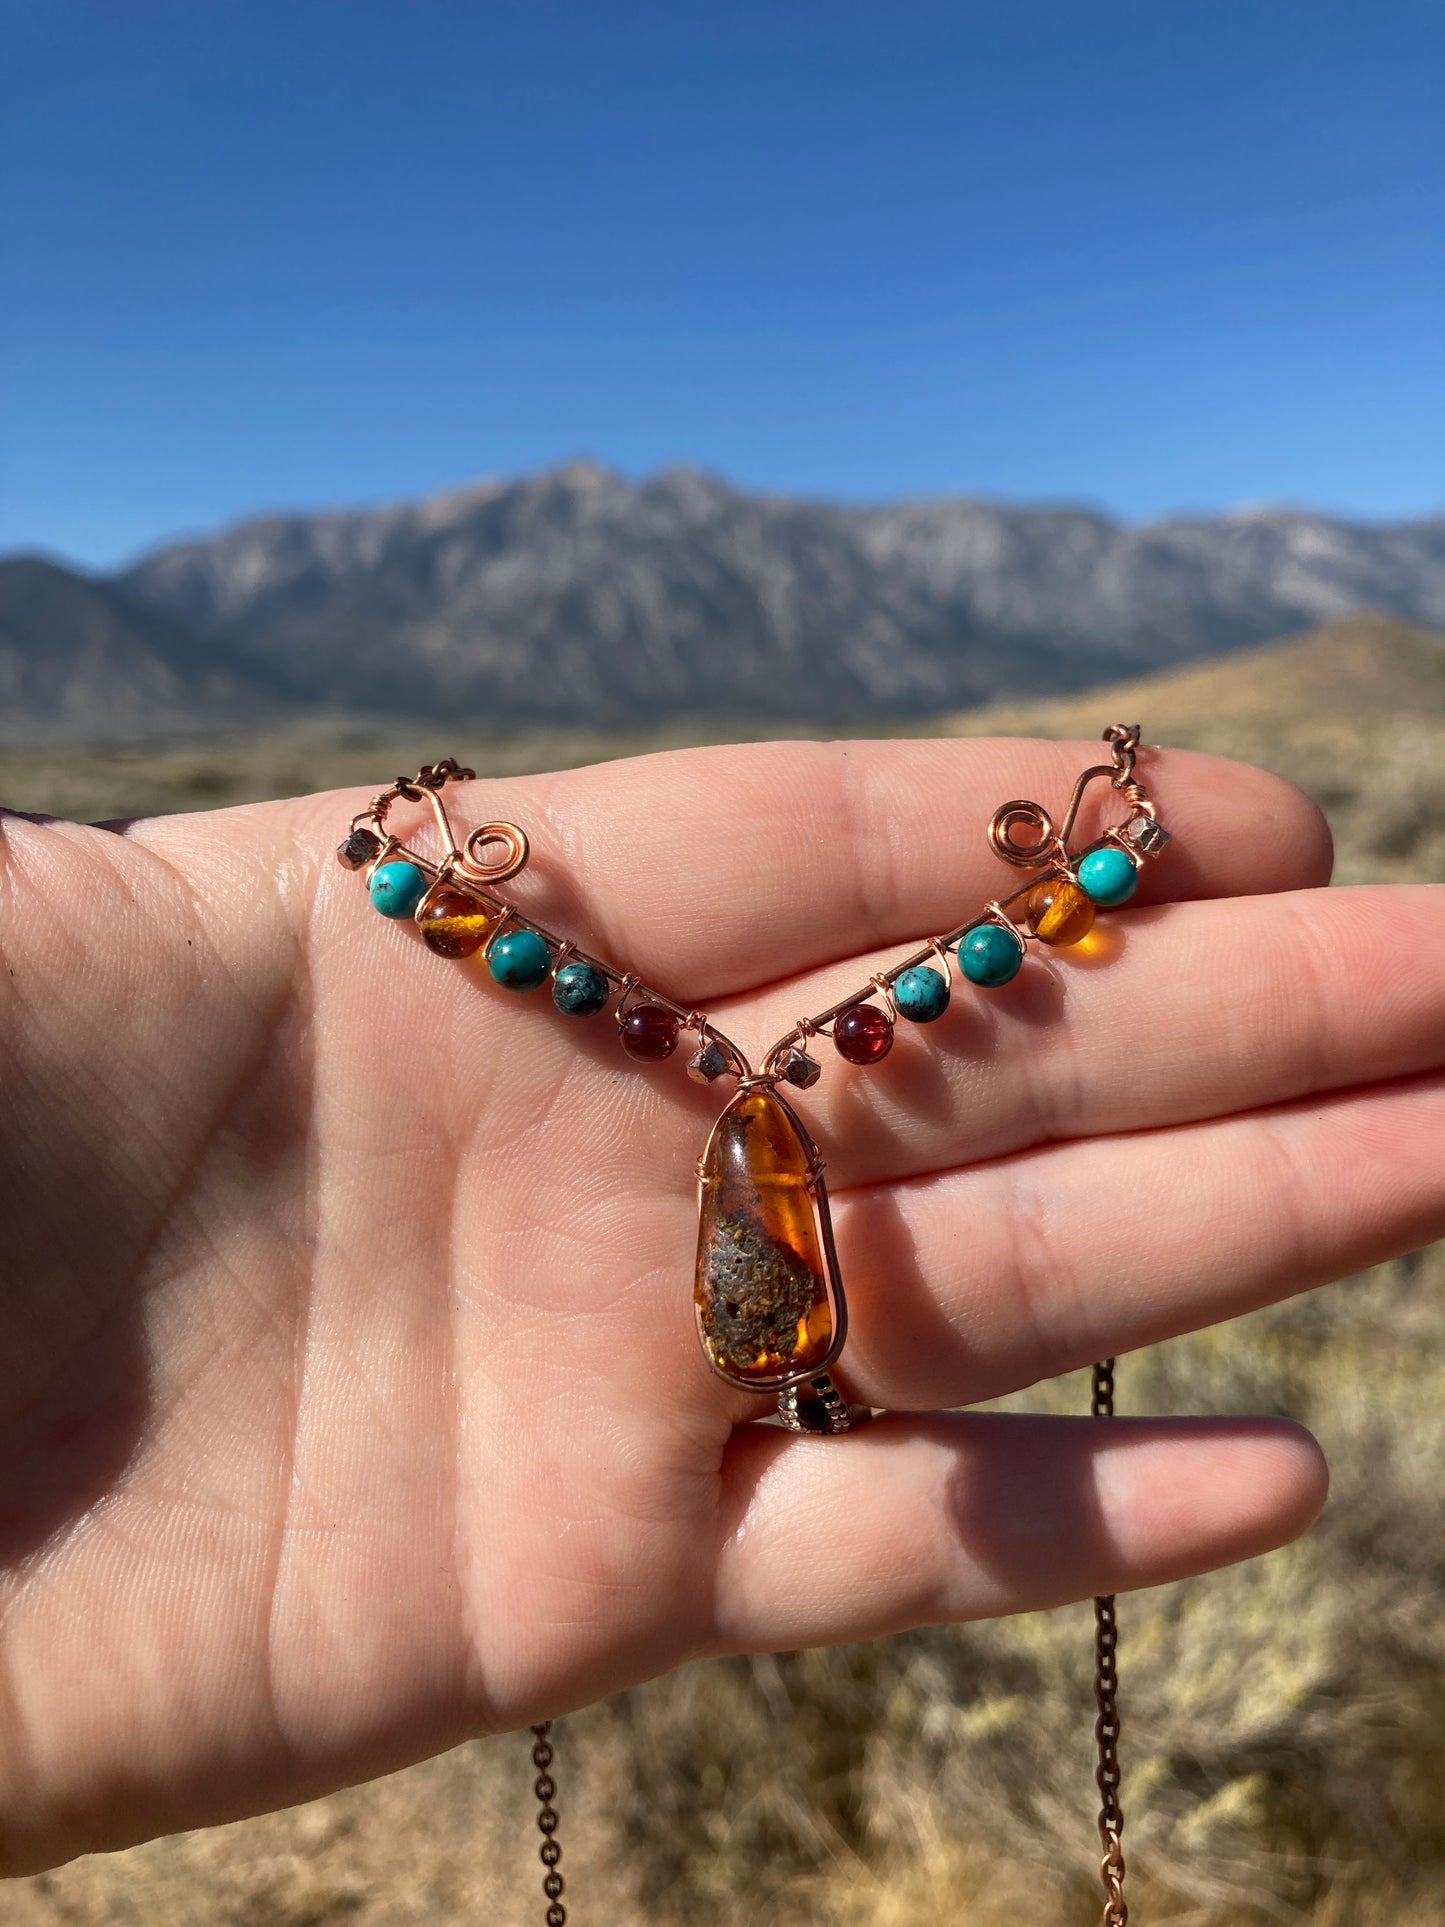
[{"left": 735, "top": 884, "right": 1445, "bottom": 1187}]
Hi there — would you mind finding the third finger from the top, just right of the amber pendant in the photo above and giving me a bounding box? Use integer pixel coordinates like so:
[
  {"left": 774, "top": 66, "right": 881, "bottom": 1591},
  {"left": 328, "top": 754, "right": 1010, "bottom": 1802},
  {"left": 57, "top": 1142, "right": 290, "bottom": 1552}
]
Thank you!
[{"left": 838, "top": 1075, "right": 1445, "bottom": 1411}]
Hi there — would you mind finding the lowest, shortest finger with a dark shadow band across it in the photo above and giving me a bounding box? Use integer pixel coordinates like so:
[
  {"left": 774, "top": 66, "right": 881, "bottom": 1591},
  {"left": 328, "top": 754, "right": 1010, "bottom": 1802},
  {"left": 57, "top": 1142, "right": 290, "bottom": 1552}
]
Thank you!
[{"left": 713, "top": 1414, "right": 1327, "bottom": 1651}]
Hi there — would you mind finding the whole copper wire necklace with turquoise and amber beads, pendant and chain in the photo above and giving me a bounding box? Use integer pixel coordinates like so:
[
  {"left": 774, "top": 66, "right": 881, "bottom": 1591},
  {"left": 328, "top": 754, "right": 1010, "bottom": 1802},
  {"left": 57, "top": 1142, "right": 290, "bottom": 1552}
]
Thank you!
[{"left": 337, "top": 723, "right": 1169, "bottom": 1927}]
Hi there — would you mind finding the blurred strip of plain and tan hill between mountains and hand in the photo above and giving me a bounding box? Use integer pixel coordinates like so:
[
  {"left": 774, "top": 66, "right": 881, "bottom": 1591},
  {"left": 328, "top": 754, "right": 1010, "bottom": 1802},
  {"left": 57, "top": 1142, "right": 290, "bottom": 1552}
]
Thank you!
[{"left": 0, "top": 617, "right": 1445, "bottom": 865}]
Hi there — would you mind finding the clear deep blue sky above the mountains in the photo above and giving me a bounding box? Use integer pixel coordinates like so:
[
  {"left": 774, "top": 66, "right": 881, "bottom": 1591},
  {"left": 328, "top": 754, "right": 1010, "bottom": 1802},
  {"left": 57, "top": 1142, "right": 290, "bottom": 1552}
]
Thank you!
[{"left": 0, "top": 0, "right": 1445, "bottom": 565}]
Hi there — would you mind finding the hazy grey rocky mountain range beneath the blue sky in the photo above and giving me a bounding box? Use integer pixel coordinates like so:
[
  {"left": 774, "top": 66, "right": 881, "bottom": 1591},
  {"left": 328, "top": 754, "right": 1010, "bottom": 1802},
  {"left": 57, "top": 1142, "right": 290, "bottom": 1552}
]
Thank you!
[{"left": 0, "top": 462, "right": 1445, "bottom": 742}]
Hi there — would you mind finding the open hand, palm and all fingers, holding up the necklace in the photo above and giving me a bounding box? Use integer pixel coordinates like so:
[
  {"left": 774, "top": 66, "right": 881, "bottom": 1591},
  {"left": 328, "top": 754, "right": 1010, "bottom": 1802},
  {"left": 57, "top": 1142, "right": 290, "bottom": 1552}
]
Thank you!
[{"left": 0, "top": 742, "right": 1445, "bottom": 1873}]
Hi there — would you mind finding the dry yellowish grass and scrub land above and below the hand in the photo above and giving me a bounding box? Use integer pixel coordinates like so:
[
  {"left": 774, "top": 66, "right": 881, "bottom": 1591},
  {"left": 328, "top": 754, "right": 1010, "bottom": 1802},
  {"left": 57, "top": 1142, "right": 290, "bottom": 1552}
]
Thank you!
[{"left": 0, "top": 620, "right": 1445, "bottom": 1927}]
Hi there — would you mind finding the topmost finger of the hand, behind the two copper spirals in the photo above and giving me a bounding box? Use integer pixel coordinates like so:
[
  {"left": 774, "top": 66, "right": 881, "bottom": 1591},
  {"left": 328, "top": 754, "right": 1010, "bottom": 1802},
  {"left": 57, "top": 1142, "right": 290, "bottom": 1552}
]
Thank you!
[{"left": 153, "top": 740, "right": 1329, "bottom": 1004}]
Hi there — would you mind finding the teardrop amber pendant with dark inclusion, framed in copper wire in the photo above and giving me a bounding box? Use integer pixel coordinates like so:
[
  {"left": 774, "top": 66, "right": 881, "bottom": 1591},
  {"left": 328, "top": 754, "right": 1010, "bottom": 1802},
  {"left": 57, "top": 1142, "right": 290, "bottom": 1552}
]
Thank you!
[{"left": 694, "top": 1085, "right": 848, "bottom": 1391}]
